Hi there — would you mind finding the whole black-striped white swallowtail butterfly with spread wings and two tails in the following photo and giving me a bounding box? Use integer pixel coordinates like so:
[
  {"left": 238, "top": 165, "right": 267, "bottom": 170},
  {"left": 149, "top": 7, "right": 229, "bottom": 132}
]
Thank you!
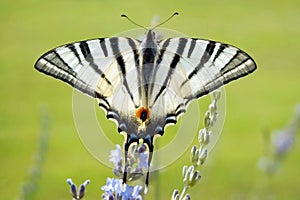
[{"left": 35, "top": 13, "right": 256, "bottom": 189}]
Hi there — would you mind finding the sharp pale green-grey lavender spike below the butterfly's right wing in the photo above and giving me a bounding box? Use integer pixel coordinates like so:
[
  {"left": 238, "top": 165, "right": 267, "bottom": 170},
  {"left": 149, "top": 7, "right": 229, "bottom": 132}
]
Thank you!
[{"left": 172, "top": 90, "right": 221, "bottom": 200}]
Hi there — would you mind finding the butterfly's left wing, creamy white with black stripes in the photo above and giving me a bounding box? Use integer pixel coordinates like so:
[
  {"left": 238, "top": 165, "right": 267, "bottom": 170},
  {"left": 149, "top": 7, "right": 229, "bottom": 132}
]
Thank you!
[{"left": 35, "top": 37, "right": 140, "bottom": 120}]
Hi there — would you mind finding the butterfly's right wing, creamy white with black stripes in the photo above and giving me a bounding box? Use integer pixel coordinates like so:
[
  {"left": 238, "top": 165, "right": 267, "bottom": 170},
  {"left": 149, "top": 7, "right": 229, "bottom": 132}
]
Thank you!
[{"left": 152, "top": 38, "right": 256, "bottom": 127}]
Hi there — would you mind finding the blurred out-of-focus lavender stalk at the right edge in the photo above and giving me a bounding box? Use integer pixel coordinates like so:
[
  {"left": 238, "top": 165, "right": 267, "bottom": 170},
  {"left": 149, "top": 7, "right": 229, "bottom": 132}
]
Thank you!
[{"left": 251, "top": 104, "right": 300, "bottom": 199}]
